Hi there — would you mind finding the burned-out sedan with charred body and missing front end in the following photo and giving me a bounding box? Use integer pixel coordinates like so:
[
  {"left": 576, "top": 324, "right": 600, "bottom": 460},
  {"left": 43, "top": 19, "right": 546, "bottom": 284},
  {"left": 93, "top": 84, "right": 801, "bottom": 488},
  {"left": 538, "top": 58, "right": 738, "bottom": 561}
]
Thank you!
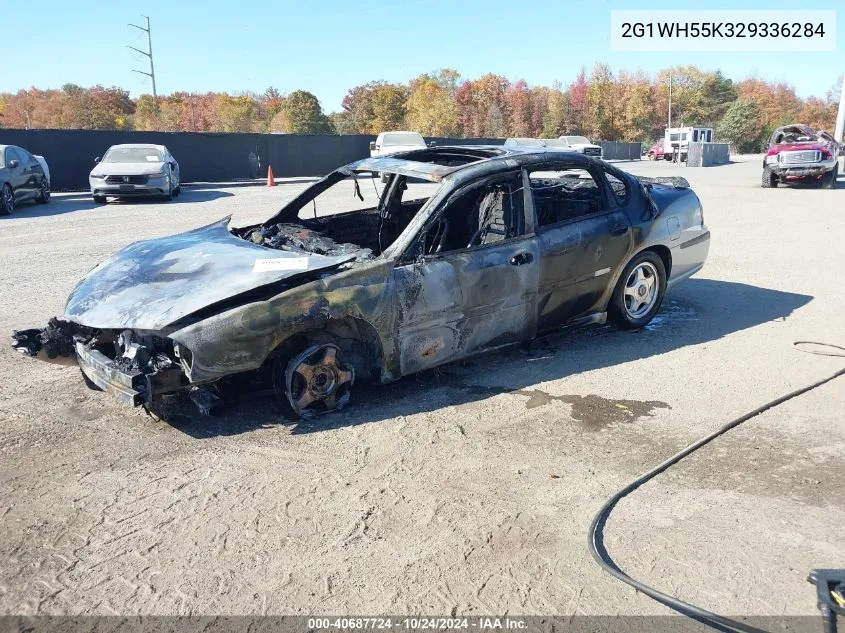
[{"left": 13, "top": 146, "right": 710, "bottom": 416}]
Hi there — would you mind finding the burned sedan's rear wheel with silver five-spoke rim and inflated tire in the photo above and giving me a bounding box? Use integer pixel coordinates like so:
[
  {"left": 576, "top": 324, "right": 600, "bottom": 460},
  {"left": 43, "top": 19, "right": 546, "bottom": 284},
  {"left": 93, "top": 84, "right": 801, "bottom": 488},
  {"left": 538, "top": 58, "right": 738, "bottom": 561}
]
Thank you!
[{"left": 607, "top": 251, "right": 666, "bottom": 330}]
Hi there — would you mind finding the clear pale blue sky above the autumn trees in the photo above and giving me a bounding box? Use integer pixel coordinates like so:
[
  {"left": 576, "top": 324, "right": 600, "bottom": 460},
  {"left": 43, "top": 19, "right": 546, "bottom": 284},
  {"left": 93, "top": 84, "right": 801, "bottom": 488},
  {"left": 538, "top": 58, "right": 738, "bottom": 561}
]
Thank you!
[{"left": 0, "top": 0, "right": 845, "bottom": 112}]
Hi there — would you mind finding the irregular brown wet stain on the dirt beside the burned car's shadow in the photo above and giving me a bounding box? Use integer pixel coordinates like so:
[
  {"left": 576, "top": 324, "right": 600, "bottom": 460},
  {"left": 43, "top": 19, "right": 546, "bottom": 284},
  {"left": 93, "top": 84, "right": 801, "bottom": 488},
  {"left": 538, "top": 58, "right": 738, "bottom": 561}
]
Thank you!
[{"left": 459, "top": 385, "right": 672, "bottom": 431}]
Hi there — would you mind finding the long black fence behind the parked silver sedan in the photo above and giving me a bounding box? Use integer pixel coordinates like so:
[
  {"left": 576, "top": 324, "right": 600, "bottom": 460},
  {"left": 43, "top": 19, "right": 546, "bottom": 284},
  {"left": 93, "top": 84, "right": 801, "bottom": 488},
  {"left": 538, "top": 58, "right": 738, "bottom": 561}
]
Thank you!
[{"left": 0, "top": 129, "right": 503, "bottom": 191}]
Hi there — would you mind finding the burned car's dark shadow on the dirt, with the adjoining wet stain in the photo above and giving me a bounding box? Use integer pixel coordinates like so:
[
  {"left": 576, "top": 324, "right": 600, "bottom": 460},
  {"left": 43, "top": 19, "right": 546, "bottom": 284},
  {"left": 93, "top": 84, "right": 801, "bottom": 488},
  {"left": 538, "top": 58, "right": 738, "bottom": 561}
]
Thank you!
[{"left": 158, "top": 279, "right": 812, "bottom": 438}]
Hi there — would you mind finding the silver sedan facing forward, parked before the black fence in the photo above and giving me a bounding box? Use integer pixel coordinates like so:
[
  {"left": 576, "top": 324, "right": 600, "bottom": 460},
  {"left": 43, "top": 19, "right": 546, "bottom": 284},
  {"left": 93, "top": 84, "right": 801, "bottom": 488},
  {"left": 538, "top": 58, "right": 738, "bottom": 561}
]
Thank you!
[{"left": 88, "top": 143, "right": 181, "bottom": 203}]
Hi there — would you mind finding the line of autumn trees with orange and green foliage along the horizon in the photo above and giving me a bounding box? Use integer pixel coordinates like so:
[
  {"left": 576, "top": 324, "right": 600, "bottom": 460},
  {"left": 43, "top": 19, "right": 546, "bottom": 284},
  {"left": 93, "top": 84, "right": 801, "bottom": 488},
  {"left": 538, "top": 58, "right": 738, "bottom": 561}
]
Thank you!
[{"left": 0, "top": 63, "right": 842, "bottom": 151}]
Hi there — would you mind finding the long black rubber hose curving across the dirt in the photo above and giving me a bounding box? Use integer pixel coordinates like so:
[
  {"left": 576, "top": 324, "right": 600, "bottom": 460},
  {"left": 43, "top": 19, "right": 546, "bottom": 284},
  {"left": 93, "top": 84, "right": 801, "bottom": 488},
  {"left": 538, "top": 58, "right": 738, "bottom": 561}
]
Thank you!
[{"left": 588, "top": 341, "right": 845, "bottom": 633}]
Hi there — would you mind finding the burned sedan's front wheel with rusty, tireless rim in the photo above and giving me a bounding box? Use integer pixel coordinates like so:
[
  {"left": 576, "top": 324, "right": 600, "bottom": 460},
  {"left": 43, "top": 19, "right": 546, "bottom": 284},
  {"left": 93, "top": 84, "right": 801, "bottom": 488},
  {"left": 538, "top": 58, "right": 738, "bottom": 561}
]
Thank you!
[{"left": 273, "top": 343, "right": 355, "bottom": 418}]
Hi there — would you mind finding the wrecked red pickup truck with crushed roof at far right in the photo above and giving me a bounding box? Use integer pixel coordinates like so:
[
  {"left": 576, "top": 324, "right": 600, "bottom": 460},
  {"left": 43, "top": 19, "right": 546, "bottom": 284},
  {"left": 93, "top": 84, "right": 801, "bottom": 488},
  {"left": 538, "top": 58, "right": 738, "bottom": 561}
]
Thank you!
[{"left": 761, "top": 124, "right": 840, "bottom": 189}]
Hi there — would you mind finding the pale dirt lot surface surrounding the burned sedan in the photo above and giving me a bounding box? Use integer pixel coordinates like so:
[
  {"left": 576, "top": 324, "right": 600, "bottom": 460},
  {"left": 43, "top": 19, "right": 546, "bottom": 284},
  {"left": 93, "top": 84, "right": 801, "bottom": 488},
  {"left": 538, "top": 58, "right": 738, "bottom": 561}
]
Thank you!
[{"left": 0, "top": 157, "right": 845, "bottom": 615}]
